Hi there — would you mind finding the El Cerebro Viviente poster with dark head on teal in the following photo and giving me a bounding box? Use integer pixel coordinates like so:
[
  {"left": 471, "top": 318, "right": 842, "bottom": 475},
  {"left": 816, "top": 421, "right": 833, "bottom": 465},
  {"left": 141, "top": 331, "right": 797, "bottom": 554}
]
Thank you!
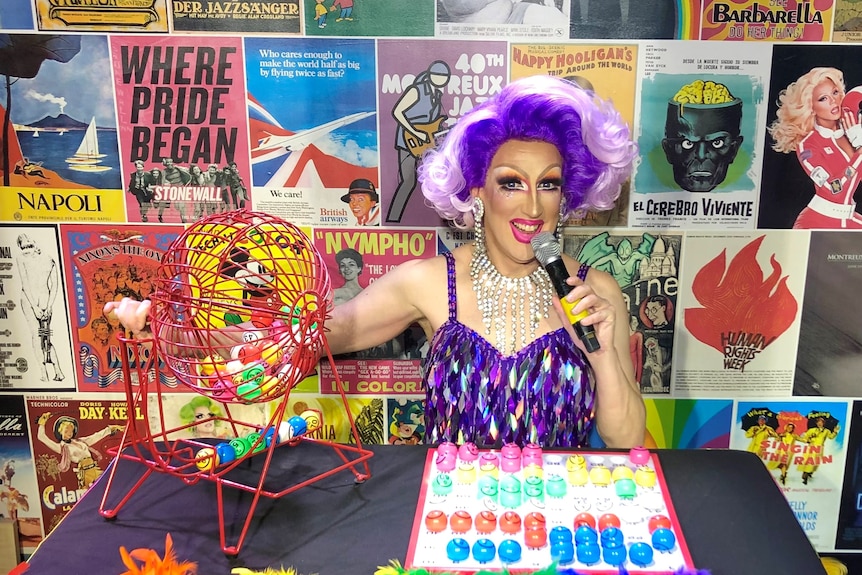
[{"left": 629, "top": 42, "right": 769, "bottom": 229}]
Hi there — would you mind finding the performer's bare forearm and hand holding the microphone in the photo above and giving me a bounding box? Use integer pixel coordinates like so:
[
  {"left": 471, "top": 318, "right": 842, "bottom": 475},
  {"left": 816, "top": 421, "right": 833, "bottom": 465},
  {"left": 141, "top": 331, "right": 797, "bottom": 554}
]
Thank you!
[{"left": 566, "top": 259, "right": 646, "bottom": 448}]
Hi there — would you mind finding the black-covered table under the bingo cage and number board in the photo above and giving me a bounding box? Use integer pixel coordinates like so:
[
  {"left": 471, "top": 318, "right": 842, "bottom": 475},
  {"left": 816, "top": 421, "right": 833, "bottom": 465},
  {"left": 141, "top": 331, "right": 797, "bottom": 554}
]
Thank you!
[{"left": 27, "top": 443, "right": 824, "bottom": 575}]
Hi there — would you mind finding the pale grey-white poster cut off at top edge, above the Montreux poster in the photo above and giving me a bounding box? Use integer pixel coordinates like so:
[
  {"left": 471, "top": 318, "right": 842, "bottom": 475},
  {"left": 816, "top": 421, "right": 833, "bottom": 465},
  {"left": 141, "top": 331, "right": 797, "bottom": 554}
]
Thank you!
[{"left": 435, "top": 0, "right": 572, "bottom": 39}]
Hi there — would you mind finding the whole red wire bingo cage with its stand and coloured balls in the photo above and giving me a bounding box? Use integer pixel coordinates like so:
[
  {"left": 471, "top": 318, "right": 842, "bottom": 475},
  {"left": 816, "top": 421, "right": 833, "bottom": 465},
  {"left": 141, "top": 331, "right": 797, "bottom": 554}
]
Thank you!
[{"left": 99, "top": 210, "right": 372, "bottom": 555}]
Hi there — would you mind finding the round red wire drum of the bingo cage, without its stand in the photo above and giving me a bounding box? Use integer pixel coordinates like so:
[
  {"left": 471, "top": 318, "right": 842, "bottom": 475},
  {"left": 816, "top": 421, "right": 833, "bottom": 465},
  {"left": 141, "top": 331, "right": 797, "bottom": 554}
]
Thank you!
[{"left": 150, "top": 210, "right": 332, "bottom": 403}]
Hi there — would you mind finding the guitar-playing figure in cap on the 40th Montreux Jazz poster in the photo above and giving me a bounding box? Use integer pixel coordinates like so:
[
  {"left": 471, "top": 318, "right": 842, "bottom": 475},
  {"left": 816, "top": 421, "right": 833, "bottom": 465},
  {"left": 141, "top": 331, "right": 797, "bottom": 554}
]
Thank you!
[{"left": 386, "top": 60, "right": 451, "bottom": 222}]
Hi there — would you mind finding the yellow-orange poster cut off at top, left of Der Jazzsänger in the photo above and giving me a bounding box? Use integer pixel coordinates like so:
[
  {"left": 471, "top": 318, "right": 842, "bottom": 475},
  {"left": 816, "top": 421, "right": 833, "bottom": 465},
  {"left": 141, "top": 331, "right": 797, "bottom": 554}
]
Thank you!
[{"left": 35, "top": 0, "right": 168, "bottom": 32}]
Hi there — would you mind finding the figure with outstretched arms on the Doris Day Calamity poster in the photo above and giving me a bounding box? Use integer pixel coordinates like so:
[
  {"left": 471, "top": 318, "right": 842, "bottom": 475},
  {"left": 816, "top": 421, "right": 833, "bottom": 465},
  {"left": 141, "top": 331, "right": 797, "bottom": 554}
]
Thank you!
[{"left": 36, "top": 411, "right": 123, "bottom": 489}]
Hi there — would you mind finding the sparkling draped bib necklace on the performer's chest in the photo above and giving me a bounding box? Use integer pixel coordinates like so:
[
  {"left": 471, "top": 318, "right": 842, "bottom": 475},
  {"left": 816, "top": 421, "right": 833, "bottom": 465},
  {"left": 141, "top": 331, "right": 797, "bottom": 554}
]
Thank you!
[{"left": 470, "top": 245, "right": 554, "bottom": 355}]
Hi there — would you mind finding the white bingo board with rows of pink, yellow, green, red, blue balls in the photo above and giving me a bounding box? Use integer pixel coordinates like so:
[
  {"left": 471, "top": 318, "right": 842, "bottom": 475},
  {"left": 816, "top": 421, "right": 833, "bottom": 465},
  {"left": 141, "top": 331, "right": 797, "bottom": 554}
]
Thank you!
[{"left": 405, "top": 443, "right": 694, "bottom": 575}]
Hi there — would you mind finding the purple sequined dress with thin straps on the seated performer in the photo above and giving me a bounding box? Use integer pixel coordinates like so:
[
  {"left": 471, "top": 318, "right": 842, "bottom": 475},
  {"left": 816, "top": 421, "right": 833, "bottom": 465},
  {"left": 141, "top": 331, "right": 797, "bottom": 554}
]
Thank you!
[{"left": 423, "top": 253, "right": 594, "bottom": 447}]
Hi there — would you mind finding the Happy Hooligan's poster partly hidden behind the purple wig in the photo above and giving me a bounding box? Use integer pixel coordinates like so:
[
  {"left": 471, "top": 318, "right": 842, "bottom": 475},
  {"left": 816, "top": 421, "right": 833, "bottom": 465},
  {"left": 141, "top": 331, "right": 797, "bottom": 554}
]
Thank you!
[{"left": 510, "top": 44, "right": 638, "bottom": 227}]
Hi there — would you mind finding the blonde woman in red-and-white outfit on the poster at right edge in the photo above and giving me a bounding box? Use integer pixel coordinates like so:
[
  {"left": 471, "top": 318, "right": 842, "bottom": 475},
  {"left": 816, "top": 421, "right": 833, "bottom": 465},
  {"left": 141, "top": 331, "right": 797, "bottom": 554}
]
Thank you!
[{"left": 769, "top": 67, "right": 862, "bottom": 229}]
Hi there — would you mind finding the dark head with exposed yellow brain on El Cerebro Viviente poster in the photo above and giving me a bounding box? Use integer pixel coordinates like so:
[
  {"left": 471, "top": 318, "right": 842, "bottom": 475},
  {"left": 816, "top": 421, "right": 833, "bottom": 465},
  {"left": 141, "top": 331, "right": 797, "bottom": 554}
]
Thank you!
[{"left": 661, "top": 80, "right": 743, "bottom": 192}]
